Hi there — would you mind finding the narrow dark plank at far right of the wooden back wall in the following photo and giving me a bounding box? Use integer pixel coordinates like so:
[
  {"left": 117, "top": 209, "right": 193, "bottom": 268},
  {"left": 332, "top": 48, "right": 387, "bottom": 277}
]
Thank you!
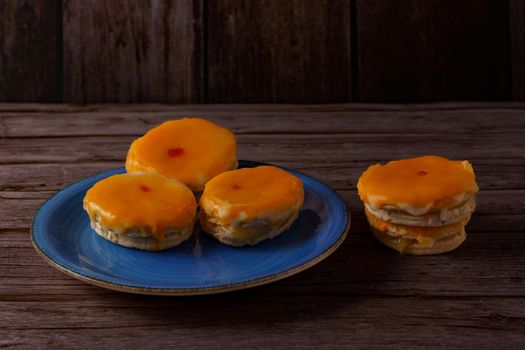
[{"left": 509, "top": 0, "right": 525, "bottom": 101}]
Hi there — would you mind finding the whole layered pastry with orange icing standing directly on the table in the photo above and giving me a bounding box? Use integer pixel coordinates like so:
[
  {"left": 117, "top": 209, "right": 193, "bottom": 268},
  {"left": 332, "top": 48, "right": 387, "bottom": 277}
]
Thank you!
[{"left": 357, "top": 156, "right": 479, "bottom": 255}]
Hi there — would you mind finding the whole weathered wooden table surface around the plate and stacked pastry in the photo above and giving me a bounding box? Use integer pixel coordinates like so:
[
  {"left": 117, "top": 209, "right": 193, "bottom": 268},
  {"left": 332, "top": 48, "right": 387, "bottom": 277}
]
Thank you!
[{"left": 0, "top": 103, "right": 525, "bottom": 349}]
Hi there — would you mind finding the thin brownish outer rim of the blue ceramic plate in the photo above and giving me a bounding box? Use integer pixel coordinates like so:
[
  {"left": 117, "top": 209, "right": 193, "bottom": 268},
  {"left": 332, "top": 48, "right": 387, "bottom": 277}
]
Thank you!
[{"left": 30, "top": 160, "right": 351, "bottom": 296}]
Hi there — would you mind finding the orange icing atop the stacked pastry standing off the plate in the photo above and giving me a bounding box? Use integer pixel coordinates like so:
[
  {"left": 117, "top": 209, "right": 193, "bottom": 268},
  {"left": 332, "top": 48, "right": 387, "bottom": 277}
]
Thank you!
[{"left": 357, "top": 156, "right": 478, "bottom": 208}]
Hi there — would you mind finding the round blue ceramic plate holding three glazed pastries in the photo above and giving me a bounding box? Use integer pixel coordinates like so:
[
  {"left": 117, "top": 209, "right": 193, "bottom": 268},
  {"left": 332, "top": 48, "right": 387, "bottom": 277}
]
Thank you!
[{"left": 32, "top": 161, "right": 349, "bottom": 295}]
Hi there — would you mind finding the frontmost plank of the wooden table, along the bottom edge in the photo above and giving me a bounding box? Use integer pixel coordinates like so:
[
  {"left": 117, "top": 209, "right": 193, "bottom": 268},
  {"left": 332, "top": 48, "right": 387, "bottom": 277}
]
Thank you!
[{"left": 1, "top": 294, "right": 524, "bottom": 349}]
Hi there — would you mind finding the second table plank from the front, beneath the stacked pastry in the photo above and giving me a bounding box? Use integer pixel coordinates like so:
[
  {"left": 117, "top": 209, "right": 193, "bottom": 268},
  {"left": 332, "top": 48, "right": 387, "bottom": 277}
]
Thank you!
[{"left": 0, "top": 225, "right": 525, "bottom": 304}]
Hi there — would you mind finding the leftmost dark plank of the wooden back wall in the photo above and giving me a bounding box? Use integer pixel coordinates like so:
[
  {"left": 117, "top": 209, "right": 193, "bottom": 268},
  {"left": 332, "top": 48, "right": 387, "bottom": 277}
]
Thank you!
[{"left": 0, "top": 0, "right": 62, "bottom": 102}]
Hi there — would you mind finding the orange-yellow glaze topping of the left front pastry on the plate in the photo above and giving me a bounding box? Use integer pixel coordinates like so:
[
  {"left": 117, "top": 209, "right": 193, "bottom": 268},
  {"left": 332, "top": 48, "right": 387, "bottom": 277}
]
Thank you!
[{"left": 84, "top": 174, "right": 197, "bottom": 240}]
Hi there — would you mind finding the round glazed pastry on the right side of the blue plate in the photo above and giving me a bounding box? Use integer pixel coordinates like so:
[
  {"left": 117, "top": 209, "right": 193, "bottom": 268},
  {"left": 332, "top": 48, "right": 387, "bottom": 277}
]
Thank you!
[{"left": 199, "top": 166, "right": 304, "bottom": 246}]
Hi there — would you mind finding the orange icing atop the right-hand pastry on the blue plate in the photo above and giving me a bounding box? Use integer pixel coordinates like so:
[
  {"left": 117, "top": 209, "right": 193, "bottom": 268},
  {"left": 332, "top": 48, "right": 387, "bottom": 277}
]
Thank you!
[{"left": 200, "top": 166, "right": 304, "bottom": 222}]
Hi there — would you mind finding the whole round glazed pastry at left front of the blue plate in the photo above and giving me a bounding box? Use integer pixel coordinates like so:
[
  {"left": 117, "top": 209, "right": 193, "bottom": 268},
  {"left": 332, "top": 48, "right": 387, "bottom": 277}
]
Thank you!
[{"left": 84, "top": 174, "right": 197, "bottom": 250}]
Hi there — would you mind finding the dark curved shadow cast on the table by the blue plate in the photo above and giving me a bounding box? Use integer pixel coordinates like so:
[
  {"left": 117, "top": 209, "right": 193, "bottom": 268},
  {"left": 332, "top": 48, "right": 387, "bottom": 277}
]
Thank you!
[{"left": 83, "top": 212, "right": 406, "bottom": 329}]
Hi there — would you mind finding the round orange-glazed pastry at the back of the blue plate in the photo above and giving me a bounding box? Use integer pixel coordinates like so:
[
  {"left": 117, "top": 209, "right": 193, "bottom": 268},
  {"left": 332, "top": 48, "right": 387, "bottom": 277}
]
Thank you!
[{"left": 126, "top": 118, "right": 238, "bottom": 192}]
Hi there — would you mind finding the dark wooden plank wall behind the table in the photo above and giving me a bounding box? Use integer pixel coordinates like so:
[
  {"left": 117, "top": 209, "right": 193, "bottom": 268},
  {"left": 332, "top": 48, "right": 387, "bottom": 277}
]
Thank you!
[{"left": 0, "top": 0, "right": 525, "bottom": 103}]
